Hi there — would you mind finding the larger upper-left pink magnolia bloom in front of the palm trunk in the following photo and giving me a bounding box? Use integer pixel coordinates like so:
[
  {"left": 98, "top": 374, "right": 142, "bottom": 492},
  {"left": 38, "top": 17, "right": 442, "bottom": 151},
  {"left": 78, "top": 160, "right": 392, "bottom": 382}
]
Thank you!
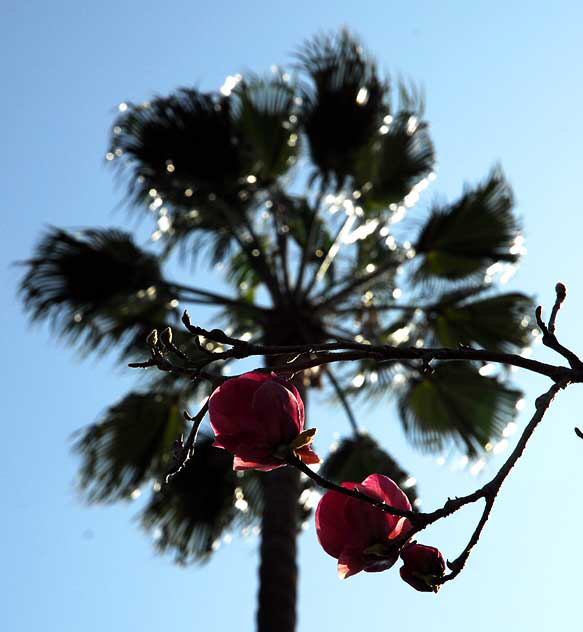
[{"left": 209, "top": 372, "right": 320, "bottom": 471}]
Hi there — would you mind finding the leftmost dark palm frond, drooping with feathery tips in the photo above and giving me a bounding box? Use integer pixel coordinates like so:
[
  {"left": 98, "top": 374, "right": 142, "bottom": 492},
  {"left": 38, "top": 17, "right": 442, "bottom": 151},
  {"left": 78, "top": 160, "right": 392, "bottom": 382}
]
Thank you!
[{"left": 20, "top": 228, "right": 178, "bottom": 353}]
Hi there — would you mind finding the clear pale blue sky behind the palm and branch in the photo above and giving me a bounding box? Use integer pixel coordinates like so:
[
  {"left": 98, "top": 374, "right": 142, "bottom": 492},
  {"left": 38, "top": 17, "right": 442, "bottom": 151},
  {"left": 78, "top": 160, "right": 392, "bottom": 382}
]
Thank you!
[{"left": 0, "top": 0, "right": 583, "bottom": 632}]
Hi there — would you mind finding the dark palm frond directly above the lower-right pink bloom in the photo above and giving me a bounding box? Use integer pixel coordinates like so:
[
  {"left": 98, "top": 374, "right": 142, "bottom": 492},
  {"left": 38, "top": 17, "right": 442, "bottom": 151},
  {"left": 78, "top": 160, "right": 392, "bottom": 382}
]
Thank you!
[{"left": 320, "top": 434, "right": 417, "bottom": 504}]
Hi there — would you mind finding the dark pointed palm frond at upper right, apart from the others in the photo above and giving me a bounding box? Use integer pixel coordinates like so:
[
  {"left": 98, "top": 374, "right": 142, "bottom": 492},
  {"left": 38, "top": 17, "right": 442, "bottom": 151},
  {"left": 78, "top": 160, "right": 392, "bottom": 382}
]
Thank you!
[{"left": 415, "top": 169, "right": 520, "bottom": 281}]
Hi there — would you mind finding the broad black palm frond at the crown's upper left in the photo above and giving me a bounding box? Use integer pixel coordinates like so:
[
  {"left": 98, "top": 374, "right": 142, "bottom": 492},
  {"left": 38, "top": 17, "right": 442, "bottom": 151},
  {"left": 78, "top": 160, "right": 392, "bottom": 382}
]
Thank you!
[{"left": 111, "top": 88, "right": 245, "bottom": 208}]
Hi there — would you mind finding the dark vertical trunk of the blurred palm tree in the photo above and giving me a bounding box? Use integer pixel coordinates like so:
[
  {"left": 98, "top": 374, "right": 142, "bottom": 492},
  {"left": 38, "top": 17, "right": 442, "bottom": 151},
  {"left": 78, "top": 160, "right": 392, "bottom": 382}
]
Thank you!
[{"left": 257, "top": 375, "right": 307, "bottom": 632}]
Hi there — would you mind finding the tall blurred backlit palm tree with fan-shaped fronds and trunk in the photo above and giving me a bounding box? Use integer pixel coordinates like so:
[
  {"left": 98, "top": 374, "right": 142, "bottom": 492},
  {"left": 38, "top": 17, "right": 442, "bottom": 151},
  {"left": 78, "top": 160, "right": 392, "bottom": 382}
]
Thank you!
[{"left": 21, "top": 31, "right": 530, "bottom": 632}]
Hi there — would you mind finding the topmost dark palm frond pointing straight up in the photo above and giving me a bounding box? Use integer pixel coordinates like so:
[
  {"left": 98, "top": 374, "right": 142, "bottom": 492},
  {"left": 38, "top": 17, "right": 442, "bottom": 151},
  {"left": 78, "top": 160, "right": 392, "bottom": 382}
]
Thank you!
[{"left": 298, "top": 31, "right": 388, "bottom": 189}]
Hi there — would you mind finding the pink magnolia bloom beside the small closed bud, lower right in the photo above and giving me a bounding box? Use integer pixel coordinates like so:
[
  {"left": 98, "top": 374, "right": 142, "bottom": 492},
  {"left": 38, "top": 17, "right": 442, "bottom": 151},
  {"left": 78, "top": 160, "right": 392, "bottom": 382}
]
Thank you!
[{"left": 316, "top": 474, "right": 411, "bottom": 579}]
